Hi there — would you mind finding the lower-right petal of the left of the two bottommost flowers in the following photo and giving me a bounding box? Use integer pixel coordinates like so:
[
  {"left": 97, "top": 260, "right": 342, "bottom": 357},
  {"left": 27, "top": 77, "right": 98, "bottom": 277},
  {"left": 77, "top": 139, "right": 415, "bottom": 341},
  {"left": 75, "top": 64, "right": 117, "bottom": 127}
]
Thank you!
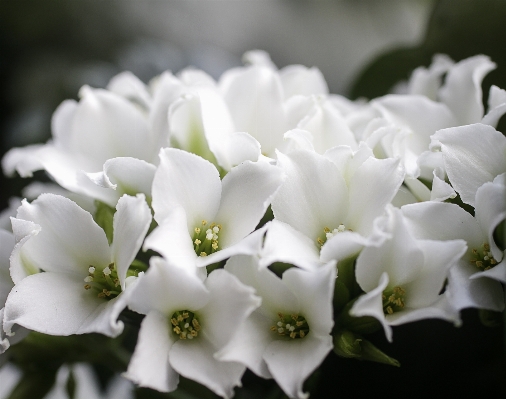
[{"left": 169, "top": 337, "right": 246, "bottom": 398}]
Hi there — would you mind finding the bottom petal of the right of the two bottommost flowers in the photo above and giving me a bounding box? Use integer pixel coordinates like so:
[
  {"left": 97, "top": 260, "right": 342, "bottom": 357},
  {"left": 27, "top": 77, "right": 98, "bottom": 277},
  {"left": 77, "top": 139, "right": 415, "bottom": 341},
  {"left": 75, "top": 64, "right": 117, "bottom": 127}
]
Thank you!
[{"left": 264, "top": 333, "right": 332, "bottom": 399}]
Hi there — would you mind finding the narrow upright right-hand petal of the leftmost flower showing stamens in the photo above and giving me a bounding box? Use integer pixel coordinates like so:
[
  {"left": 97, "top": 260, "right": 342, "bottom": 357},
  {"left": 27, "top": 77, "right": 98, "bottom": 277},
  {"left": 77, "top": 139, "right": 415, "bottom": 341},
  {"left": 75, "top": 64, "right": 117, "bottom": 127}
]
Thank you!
[{"left": 111, "top": 194, "right": 151, "bottom": 290}]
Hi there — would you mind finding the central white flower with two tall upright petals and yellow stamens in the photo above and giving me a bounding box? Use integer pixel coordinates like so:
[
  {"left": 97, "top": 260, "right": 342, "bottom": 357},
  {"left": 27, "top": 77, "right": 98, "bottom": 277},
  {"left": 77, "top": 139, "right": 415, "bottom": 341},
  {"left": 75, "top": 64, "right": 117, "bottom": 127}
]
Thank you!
[{"left": 145, "top": 149, "right": 283, "bottom": 270}]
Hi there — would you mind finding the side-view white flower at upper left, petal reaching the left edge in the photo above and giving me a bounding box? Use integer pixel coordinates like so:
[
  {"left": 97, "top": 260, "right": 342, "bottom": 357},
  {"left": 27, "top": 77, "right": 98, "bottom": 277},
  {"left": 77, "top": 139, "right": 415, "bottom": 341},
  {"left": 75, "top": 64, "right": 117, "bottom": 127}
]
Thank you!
[{"left": 2, "top": 86, "right": 160, "bottom": 206}]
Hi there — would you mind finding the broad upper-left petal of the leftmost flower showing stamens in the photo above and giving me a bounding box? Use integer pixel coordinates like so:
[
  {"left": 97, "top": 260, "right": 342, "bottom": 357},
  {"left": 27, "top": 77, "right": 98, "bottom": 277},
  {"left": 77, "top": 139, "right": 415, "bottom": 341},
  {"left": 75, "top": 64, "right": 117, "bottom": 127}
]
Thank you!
[{"left": 12, "top": 194, "right": 110, "bottom": 278}]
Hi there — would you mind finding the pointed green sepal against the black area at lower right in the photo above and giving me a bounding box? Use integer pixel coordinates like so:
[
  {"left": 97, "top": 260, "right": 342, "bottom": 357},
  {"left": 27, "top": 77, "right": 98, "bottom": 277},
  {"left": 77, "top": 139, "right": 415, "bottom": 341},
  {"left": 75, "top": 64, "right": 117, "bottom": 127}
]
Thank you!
[{"left": 333, "top": 330, "right": 400, "bottom": 367}]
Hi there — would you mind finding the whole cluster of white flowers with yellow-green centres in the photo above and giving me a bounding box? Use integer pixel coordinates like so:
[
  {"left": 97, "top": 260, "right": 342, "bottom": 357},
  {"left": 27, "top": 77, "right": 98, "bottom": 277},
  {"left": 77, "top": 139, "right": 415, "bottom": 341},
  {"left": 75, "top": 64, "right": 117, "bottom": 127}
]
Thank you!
[{"left": 0, "top": 51, "right": 506, "bottom": 398}]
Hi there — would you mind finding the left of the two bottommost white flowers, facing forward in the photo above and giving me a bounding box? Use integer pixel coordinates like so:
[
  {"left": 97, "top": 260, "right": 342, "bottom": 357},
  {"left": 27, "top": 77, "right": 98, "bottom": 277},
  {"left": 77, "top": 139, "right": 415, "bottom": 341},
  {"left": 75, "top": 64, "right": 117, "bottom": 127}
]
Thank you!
[{"left": 125, "top": 257, "right": 259, "bottom": 398}]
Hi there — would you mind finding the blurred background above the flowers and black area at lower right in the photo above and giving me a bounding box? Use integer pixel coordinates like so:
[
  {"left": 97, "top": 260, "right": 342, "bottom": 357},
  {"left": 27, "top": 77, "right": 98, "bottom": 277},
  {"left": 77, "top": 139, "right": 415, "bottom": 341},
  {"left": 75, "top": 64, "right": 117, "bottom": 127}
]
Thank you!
[{"left": 0, "top": 0, "right": 506, "bottom": 398}]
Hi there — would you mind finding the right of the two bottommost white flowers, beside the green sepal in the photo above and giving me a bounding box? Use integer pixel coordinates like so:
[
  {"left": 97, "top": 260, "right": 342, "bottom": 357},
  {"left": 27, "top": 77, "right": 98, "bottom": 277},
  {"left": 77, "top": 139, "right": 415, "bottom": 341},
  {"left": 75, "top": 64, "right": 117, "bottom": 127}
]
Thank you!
[{"left": 217, "top": 255, "right": 336, "bottom": 398}]
